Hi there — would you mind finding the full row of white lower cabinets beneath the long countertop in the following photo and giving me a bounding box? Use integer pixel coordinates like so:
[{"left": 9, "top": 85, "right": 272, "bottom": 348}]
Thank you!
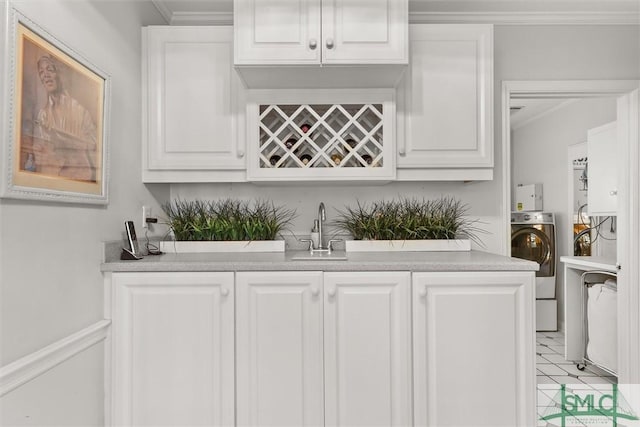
[{"left": 105, "top": 271, "right": 536, "bottom": 427}]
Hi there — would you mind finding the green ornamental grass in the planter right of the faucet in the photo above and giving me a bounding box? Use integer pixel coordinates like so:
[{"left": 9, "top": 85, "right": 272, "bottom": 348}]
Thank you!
[{"left": 334, "top": 197, "right": 483, "bottom": 244}]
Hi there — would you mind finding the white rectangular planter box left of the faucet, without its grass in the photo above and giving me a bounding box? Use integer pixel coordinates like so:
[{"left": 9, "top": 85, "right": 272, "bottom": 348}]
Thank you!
[{"left": 160, "top": 240, "right": 284, "bottom": 253}]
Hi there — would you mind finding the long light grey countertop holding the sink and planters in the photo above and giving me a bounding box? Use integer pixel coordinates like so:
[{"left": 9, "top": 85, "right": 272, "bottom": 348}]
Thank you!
[{"left": 101, "top": 251, "right": 538, "bottom": 272}]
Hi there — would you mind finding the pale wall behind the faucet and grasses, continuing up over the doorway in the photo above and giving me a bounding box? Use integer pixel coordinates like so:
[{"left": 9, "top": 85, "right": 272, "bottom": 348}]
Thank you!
[{"left": 171, "top": 25, "right": 640, "bottom": 253}]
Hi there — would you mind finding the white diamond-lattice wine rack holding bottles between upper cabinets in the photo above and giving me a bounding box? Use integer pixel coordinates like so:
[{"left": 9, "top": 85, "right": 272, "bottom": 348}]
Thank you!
[{"left": 247, "top": 90, "right": 395, "bottom": 181}]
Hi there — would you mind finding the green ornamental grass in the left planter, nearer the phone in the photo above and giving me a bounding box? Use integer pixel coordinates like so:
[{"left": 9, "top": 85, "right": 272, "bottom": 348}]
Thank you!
[{"left": 162, "top": 199, "right": 295, "bottom": 241}]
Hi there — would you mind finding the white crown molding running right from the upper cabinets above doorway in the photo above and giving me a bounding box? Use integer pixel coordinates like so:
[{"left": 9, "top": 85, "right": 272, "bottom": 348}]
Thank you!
[{"left": 409, "top": 12, "right": 640, "bottom": 25}]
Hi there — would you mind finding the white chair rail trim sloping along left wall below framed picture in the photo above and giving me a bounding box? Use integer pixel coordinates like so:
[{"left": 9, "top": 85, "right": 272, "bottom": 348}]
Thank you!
[{"left": 0, "top": 320, "right": 111, "bottom": 396}]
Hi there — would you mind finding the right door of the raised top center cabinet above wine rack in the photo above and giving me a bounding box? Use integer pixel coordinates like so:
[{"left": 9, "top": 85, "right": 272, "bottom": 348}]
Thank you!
[{"left": 322, "top": 0, "right": 409, "bottom": 64}]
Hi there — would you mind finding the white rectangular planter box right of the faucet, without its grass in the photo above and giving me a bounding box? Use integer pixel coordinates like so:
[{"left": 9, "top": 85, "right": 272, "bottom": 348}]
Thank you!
[{"left": 345, "top": 239, "right": 471, "bottom": 252}]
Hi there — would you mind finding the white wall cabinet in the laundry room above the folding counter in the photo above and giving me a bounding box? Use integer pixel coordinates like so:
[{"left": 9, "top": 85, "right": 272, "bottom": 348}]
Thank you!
[{"left": 587, "top": 122, "right": 618, "bottom": 216}]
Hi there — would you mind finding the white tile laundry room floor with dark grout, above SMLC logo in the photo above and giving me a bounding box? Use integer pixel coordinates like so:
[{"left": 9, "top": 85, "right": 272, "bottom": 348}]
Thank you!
[{"left": 536, "top": 332, "right": 618, "bottom": 384}]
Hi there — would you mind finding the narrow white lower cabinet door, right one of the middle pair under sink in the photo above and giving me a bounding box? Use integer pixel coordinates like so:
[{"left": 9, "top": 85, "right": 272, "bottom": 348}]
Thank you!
[{"left": 324, "top": 272, "right": 411, "bottom": 426}]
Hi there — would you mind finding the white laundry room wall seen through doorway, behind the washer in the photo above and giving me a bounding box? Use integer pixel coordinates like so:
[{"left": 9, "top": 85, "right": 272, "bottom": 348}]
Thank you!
[{"left": 511, "top": 98, "right": 616, "bottom": 325}]
